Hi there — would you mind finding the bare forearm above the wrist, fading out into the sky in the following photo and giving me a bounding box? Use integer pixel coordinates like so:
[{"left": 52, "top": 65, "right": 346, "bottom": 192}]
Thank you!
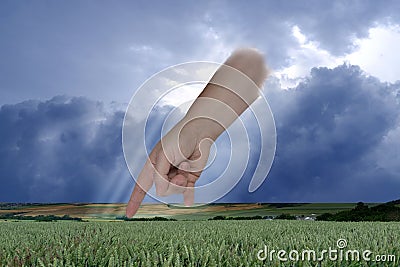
[{"left": 182, "top": 49, "right": 268, "bottom": 140}]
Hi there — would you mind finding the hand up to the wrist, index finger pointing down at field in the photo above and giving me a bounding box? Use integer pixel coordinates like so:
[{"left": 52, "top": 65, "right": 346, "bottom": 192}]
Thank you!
[{"left": 126, "top": 118, "right": 218, "bottom": 217}]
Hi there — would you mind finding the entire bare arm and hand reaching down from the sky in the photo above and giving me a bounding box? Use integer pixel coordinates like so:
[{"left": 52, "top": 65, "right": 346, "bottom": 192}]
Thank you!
[{"left": 126, "top": 49, "right": 268, "bottom": 217}]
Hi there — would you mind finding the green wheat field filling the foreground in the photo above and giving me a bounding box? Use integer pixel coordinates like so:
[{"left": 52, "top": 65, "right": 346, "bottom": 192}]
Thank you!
[{"left": 0, "top": 220, "right": 400, "bottom": 267}]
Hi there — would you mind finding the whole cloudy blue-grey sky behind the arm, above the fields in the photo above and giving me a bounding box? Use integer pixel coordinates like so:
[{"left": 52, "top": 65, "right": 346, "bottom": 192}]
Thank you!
[{"left": 0, "top": 0, "right": 400, "bottom": 202}]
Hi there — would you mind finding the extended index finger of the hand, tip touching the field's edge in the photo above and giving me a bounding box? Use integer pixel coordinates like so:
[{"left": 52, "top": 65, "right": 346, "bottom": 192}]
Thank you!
[{"left": 126, "top": 158, "right": 154, "bottom": 218}]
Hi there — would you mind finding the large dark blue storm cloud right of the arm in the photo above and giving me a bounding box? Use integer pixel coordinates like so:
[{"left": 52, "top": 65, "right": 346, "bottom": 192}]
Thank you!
[{"left": 222, "top": 65, "right": 400, "bottom": 202}]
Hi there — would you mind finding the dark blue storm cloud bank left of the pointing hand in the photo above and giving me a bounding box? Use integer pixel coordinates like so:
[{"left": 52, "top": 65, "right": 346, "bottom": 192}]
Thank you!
[{"left": 0, "top": 96, "right": 129, "bottom": 202}]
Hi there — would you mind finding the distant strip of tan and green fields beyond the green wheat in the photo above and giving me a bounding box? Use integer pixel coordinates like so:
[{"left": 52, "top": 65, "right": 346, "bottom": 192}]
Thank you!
[{"left": 0, "top": 203, "right": 360, "bottom": 220}]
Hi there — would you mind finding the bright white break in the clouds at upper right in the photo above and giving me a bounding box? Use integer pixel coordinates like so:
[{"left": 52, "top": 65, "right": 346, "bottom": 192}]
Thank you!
[{"left": 275, "top": 25, "right": 400, "bottom": 89}]
